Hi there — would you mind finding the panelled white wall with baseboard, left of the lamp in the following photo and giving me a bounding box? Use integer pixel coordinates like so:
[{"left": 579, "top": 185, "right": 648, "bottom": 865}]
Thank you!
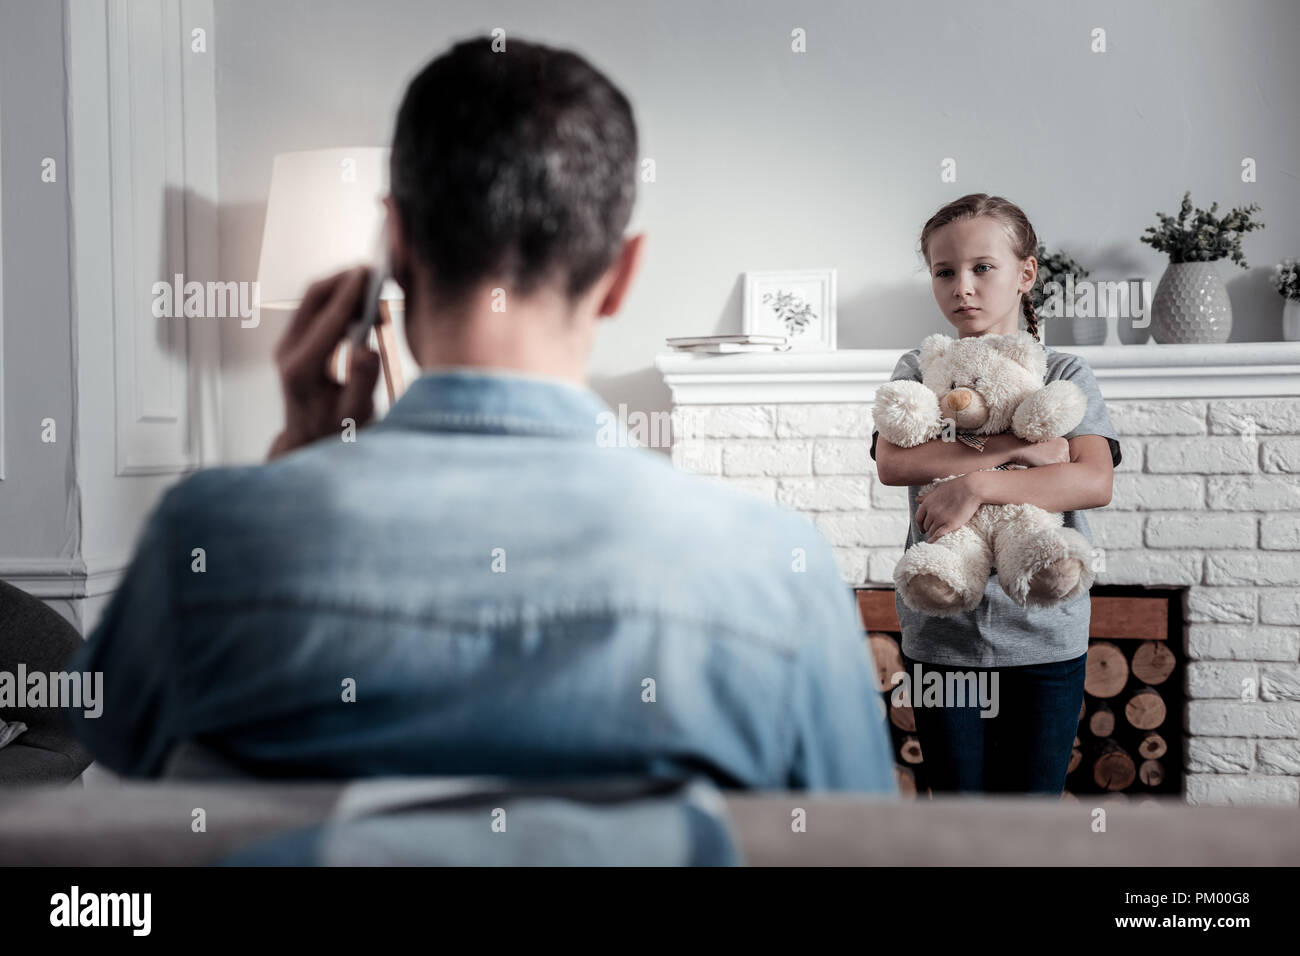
[{"left": 0, "top": 0, "right": 220, "bottom": 631}]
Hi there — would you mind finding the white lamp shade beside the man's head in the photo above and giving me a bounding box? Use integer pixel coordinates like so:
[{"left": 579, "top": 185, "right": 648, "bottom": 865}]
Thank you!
[{"left": 257, "top": 146, "right": 402, "bottom": 308}]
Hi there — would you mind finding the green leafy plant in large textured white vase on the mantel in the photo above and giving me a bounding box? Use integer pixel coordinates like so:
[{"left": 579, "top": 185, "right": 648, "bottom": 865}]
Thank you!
[{"left": 1141, "top": 191, "right": 1264, "bottom": 343}]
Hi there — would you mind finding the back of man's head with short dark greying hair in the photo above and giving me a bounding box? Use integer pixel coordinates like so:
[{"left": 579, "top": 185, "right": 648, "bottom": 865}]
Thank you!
[{"left": 390, "top": 38, "right": 637, "bottom": 314}]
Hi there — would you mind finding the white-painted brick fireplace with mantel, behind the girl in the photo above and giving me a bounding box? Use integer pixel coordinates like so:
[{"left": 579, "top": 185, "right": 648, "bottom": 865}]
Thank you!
[{"left": 657, "top": 342, "right": 1300, "bottom": 806}]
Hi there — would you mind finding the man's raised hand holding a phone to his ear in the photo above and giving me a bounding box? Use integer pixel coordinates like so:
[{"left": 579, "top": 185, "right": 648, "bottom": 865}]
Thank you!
[{"left": 267, "top": 267, "right": 380, "bottom": 459}]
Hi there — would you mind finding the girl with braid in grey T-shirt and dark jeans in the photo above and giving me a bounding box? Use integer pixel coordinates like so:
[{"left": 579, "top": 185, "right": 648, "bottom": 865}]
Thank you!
[{"left": 871, "top": 193, "right": 1121, "bottom": 795}]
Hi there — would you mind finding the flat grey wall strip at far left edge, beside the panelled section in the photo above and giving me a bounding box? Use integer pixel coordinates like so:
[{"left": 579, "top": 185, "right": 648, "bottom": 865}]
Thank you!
[{"left": 0, "top": 0, "right": 81, "bottom": 617}]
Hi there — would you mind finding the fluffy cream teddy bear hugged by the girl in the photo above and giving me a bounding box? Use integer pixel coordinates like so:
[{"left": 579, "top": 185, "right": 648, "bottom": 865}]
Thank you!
[{"left": 872, "top": 332, "right": 1095, "bottom": 617}]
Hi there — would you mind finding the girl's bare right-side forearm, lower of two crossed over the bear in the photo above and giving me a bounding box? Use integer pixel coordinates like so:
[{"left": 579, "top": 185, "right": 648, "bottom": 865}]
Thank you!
[{"left": 972, "top": 434, "right": 1114, "bottom": 512}]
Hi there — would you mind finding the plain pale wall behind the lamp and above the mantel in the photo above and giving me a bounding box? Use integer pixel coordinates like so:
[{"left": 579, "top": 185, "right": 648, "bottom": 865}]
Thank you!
[{"left": 216, "top": 0, "right": 1300, "bottom": 460}]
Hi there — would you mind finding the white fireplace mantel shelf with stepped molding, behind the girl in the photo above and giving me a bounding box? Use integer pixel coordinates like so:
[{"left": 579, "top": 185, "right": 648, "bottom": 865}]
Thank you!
[{"left": 655, "top": 342, "right": 1300, "bottom": 405}]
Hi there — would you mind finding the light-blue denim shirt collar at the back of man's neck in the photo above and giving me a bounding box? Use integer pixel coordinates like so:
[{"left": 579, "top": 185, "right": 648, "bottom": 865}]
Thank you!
[{"left": 374, "top": 365, "right": 614, "bottom": 440}]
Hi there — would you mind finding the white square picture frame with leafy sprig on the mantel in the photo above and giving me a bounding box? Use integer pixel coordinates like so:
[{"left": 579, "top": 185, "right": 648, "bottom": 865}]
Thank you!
[{"left": 742, "top": 269, "right": 836, "bottom": 351}]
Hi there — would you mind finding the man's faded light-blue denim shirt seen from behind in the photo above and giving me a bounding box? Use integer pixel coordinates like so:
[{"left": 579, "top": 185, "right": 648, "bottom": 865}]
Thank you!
[{"left": 69, "top": 368, "right": 897, "bottom": 795}]
